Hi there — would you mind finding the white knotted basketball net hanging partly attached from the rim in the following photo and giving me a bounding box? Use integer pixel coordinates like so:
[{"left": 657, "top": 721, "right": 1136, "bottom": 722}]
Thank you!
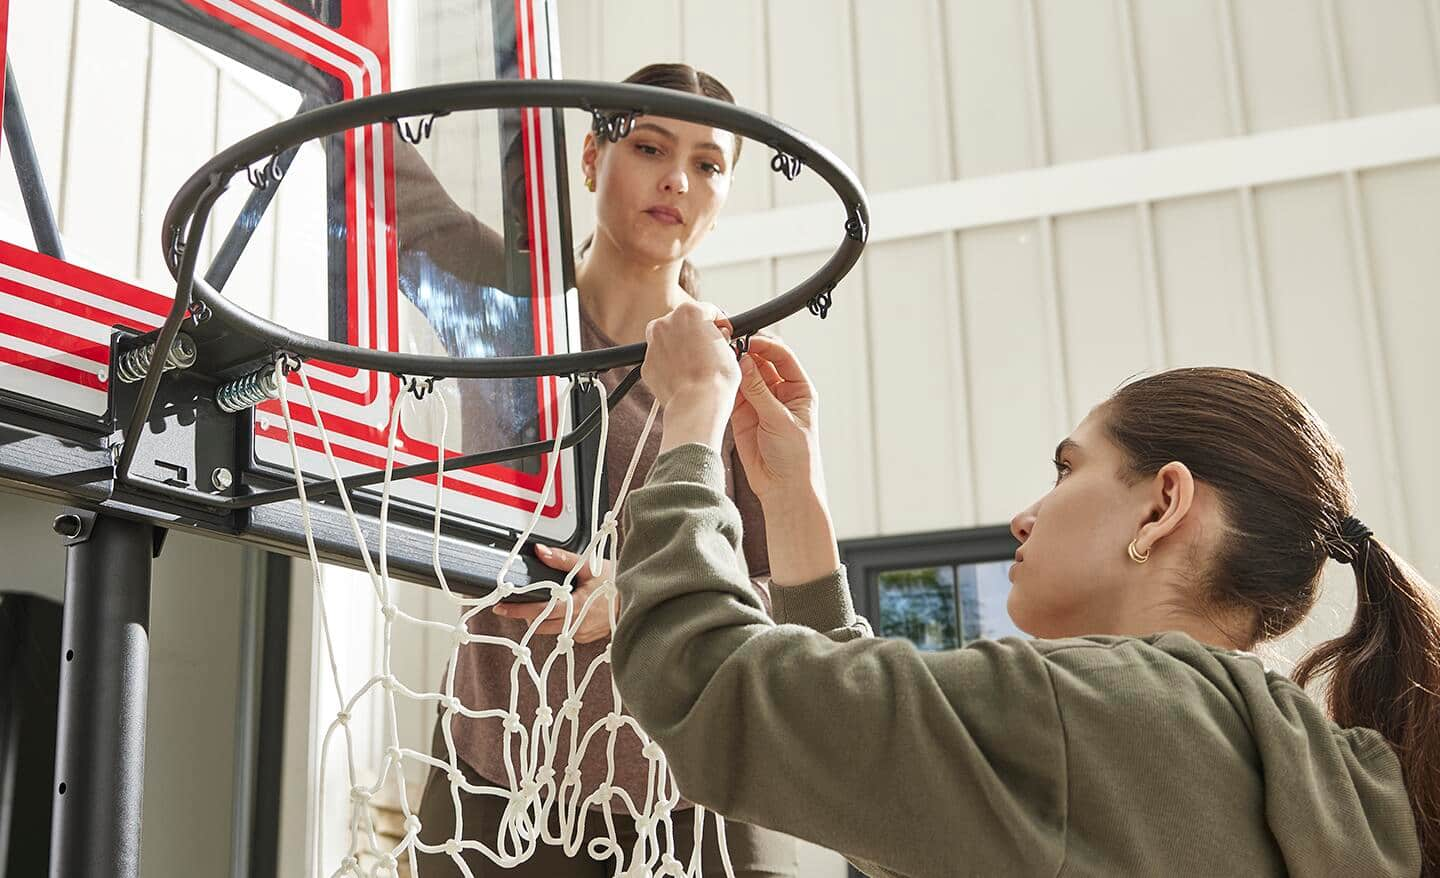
[{"left": 276, "top": 364, "right": 734, "bottom": 878}]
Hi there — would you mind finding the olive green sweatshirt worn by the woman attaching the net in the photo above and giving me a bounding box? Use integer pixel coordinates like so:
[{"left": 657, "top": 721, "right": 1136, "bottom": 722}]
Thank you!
[{"left": 613, "top": 445, "right": 1420, "bottom": 878}]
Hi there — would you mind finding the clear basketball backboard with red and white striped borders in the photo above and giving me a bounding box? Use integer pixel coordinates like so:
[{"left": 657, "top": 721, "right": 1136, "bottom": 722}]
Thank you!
[{"left": 0, "top": 0, "right": 590, "bottom": 587}]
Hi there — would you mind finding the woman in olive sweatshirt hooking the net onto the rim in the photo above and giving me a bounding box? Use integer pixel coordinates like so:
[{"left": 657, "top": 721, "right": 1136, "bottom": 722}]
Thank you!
[{"left": 613, "top": 305, "right": 1440, "bottom": 878}]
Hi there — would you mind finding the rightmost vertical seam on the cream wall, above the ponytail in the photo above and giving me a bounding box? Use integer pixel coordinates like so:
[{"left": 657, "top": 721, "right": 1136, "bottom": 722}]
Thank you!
[{"left": 1320, "top": 0, "right": 1411, "bottom": 550}]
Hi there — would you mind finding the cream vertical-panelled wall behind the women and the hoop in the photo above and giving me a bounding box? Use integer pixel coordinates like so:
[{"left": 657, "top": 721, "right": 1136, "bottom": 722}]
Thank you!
[{"left": 0, "top": 0, "right": 1440, "bottom": 878}]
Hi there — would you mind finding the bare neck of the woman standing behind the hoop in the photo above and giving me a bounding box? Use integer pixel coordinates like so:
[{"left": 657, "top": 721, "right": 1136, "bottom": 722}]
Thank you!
[{"left": 575, "top": 230, "right": 690, "bottom": 344}]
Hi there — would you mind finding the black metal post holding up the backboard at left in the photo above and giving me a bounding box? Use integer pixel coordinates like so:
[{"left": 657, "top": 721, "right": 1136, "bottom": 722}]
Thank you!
[{"left": 50, "top": 510, "right": 156, "bottom": 878}]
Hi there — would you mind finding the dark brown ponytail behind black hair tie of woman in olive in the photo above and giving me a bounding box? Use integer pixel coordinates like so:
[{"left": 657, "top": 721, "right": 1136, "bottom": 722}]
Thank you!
[{"left": 1293, "top": 535, "right": 1440, "bottom": 878}]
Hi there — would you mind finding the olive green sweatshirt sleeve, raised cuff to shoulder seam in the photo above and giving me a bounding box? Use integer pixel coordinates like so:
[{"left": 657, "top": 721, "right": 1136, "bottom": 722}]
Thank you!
[{"left": 612, "top": 445, "right": 1067, "bottom": 877}]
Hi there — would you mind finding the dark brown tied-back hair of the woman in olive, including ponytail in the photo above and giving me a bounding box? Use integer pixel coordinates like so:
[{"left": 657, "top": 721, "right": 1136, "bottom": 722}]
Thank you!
[{"left": 1104, "top": 368, "right": 1440, "bottom": 878}]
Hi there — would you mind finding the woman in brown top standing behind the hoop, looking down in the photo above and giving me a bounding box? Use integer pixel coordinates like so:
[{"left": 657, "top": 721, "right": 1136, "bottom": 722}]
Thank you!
[{"left": 414, "top": 65, "right": 796, "bottom": 878}]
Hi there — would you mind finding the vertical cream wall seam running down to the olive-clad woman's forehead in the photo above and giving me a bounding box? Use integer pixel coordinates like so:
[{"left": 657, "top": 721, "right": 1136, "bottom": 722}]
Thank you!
[{"left": 1024, "top": 0, "right": 1073, "bottom": 433}]
